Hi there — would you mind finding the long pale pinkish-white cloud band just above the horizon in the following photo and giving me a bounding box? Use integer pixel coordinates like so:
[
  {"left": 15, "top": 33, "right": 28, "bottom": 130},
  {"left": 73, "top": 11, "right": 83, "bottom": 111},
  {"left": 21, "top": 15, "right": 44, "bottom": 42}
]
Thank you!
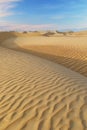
[{"left": 0, "top": 21, "right": 87, "bottom": 31}]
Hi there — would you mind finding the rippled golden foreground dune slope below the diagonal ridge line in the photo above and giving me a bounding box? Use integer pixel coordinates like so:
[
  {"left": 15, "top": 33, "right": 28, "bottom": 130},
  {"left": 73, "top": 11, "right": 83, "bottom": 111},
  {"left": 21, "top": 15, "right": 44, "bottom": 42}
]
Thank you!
[{"left": 0, "top": 47, "right": 87, "bottom": 130}]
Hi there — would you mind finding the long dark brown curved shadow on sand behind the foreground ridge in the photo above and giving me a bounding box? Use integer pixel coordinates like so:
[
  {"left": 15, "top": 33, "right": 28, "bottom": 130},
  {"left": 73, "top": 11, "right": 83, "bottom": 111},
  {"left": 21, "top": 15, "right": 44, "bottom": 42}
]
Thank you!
[{"left": 0, "top": 32, "right": 87, "bottom": 77}]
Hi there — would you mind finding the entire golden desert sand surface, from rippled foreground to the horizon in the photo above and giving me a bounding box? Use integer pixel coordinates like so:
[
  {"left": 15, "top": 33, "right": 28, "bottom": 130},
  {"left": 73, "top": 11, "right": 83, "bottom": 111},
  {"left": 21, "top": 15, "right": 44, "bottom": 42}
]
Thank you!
[{"left": 0, "top": 32, "right": 87, "bottom": 130}]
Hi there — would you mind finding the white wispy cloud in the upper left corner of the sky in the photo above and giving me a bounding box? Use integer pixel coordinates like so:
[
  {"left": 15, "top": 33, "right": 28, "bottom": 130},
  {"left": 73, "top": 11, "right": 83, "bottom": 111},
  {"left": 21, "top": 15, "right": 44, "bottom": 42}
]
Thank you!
[{"left": 0, "top": 0, "right": 20, "bottom": 17}]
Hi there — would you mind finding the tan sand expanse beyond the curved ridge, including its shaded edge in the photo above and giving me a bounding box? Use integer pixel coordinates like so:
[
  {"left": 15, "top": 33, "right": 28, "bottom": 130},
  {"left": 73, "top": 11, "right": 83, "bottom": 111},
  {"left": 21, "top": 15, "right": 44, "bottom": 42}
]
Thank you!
[{"left": 3, "top": 36, "right": 87, "bottom": 77}]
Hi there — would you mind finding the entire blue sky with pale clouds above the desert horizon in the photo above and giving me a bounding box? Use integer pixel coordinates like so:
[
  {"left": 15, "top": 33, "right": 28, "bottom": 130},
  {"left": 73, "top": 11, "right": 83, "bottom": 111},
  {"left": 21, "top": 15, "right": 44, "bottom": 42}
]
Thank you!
[{"left": 0, "top": 0, "right": 87, "bottom": 30}]
